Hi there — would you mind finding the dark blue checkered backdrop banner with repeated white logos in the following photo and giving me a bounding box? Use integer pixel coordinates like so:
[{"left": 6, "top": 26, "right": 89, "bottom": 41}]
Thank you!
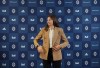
[{"left": 0, "top": 0, "right": 100, "bottom": 68}]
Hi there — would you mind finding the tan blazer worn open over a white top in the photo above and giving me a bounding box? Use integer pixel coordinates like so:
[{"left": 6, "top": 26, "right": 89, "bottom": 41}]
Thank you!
[{"left": 34, "top": 27, "right": 68, "bottom": 61}]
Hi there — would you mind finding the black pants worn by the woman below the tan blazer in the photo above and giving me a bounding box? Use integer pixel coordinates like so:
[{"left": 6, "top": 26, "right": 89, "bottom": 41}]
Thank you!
[{"left": 43, "top": 48, "right": 61, "bottom": 68}]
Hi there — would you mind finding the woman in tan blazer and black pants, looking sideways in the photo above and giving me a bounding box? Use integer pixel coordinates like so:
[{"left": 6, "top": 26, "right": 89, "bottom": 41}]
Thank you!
[{"left": 34, "top": 14, "right": 68, "bottom": 68}]
